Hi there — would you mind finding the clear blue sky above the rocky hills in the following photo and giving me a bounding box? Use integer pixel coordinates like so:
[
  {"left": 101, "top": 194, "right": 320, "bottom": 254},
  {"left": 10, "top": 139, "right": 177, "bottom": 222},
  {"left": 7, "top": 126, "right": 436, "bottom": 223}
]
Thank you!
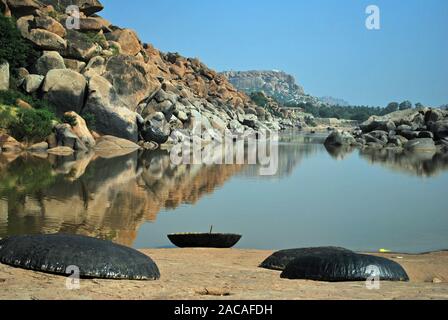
[{"left": 101, "top": 0, "right": 448, "bottom": 106}]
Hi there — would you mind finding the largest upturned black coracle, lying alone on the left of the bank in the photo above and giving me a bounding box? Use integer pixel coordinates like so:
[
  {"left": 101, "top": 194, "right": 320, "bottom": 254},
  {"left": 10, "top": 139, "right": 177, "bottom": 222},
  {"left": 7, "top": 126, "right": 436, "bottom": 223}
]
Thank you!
[{"left": 0, "top": 234, "right": 160, "bottom": 280}]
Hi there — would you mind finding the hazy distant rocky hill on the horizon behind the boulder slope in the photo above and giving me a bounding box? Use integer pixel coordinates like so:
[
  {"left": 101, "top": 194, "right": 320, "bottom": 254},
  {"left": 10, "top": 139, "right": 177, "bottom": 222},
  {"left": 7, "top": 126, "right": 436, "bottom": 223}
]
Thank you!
[{"left": 222, "top": 71, "right": 321, "bottom": 105}]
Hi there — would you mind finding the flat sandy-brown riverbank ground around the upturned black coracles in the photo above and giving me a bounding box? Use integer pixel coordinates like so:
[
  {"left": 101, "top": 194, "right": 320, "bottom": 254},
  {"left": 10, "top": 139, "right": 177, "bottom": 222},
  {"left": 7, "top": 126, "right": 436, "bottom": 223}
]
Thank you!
[{"left": 0, "top": 249, "right": 448, "bottom": 300}]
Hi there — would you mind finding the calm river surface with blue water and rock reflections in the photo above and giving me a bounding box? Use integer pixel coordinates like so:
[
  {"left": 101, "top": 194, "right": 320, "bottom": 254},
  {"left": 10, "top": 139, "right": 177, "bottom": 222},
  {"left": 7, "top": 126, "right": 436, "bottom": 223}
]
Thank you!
[{"left": 0, "top": 133, "right": 448, "bottom": 252}]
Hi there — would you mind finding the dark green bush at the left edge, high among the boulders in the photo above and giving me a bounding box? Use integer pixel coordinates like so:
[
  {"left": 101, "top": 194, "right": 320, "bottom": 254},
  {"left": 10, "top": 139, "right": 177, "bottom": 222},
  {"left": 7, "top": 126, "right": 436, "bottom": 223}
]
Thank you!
[{"left": 0, "top": 14, "right": 38, "bottom": 69}]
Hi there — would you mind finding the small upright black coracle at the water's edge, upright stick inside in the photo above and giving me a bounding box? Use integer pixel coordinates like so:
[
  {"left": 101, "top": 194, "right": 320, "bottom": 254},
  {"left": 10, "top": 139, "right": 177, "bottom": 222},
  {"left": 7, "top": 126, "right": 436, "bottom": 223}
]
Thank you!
[{"left": 168, "top": 227, "right": 242, "bottom": 248}]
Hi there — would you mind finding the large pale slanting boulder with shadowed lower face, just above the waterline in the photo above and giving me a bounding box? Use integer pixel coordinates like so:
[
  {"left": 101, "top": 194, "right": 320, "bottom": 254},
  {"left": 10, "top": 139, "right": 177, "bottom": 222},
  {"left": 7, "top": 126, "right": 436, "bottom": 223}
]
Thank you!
[{"left": 83, "top": 75, "right": 138, "bottom": 142}]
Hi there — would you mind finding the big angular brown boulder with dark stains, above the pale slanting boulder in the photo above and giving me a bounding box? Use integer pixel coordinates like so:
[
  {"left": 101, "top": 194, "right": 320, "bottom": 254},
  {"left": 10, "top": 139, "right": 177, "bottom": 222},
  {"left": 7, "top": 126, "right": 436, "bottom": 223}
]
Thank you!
[{"left": 103, "top": 55, "right": 160, "bottom": 111}]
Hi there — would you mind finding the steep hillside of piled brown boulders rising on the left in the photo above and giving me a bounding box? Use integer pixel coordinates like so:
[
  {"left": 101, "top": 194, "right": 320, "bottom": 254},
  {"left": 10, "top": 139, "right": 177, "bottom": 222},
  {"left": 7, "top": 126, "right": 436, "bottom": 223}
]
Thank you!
[{"left": 0, "top": 0, "right": 302, "bottom": 155}]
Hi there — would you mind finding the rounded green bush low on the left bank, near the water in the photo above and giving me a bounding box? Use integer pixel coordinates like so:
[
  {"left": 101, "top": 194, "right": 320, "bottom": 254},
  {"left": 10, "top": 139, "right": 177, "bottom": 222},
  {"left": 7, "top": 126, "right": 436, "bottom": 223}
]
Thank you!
[{"left": 8, "top": 109, "right": 55, "bottom": 142}]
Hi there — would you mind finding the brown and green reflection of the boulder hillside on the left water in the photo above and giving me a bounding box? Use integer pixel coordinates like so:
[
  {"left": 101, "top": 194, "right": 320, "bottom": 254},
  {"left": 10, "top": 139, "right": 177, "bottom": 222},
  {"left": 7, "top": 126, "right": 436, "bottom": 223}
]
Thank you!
[{"left": 0, "top": 144, "right": 242, "bottom": 245}]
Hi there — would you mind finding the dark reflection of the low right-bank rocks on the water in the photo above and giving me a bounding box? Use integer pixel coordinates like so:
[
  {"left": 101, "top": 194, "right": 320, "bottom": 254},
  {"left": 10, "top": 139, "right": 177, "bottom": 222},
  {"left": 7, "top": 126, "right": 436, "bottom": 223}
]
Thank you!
[{"left": 360, "top": 149, "right": 448, "bottom": 177}]
